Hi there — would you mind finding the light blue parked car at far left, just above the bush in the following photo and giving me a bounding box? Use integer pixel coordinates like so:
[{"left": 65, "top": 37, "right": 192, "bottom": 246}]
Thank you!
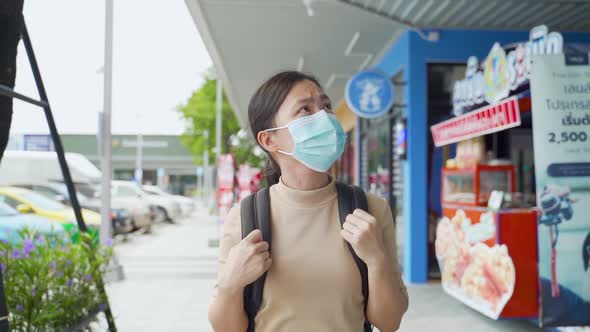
[{"left": 0, "top": 202, "right": 65, "bottom": 243}]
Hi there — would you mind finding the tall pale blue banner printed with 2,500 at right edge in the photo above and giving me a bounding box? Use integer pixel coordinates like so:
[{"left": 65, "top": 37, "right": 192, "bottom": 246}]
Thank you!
[{"left": 531, "top": 55, "right": 590, "bottom": 326}]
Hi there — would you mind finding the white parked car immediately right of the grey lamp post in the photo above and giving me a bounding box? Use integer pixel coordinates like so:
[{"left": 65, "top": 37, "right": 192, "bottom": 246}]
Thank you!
[{"left": 111, "top": 181, "right": 181, "bottom": 222}]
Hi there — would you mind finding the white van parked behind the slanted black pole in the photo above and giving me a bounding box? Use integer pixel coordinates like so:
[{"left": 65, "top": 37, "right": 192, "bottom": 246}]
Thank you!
[{"left": 0, "top": 151, "right": 102, "bottom": 185}]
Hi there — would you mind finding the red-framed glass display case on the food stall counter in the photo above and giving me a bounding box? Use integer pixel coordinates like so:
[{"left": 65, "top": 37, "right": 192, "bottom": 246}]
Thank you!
[{"left": 441, "top": 164, "right": 515, "bottom": 206}]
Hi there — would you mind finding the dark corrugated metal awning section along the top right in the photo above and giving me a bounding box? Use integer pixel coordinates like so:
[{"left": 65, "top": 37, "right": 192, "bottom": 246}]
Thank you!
[{"left": 338, "top": 0, "right": 590, "bottom": 32}]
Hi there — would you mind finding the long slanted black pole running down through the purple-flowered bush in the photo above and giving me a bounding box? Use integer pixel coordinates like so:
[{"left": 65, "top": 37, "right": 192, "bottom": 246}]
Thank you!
[{"left": 22, "top": 19, "right": 117, "bottom": 332}]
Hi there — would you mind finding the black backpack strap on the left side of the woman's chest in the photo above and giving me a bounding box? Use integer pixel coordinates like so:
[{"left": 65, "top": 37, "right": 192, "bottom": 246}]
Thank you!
[{"left": 240, "top": 187, "right": 272, "bottom": 332}]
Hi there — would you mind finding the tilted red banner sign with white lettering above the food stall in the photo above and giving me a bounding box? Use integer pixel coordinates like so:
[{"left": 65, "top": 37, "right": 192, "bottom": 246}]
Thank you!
[{"left": 430, "top": 98, "right": 520, "bottom": 146}]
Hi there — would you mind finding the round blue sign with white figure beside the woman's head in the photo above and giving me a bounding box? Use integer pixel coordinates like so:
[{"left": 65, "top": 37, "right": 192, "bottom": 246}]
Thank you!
[{"left": 344, "top": 70, "right": 394, "bottom": 118}]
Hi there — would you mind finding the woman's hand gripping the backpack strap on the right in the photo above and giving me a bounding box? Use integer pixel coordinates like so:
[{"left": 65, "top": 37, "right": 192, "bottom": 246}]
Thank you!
[{"left": 340, "top": 209, "right": 386, "bottom": 267}]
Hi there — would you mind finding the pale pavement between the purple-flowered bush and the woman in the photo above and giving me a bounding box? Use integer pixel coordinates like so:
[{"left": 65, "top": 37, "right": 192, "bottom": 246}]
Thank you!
[{"left": 107, "top": 205, "right": 217, "bottom": 332}]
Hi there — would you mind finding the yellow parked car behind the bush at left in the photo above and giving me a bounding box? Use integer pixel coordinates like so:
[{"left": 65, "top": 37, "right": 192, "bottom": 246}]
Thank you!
[{"left": 0, "top": 187, "right": 100, "bottom": 239}]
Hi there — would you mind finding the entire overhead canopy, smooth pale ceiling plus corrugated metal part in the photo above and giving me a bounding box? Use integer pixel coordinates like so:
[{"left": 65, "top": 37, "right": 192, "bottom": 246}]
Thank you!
[{"left": 185, "top": 0, "right": 590, "bottom": 127}]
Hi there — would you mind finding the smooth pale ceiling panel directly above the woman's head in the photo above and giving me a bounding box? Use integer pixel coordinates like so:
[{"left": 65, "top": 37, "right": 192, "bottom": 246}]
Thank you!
[{"left": 186, "top": 0, "right": 404, "bottom": 127}]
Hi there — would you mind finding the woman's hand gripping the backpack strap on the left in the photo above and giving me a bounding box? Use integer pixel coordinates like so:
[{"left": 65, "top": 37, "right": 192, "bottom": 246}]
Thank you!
[{"left": 218, "top": 229, "right": 272, "bottom": 291}]
